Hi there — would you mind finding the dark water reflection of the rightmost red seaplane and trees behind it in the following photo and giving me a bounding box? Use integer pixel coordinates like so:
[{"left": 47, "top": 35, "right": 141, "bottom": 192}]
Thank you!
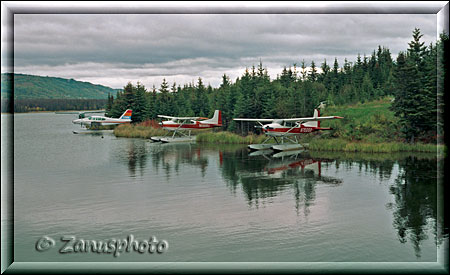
[{"left": 221, "top": 150, "right": 342, "bottom": 215}]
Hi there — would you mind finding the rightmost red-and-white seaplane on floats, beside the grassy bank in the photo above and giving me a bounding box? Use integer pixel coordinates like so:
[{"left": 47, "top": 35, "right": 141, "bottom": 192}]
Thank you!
[{"left": 233, "top": 108, "right": 343, "bottom": 152}]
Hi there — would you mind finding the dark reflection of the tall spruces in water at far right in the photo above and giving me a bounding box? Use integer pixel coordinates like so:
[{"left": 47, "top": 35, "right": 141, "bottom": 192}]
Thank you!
[{"left": 389, "top": 157, "right": 442, "bottom": 258}]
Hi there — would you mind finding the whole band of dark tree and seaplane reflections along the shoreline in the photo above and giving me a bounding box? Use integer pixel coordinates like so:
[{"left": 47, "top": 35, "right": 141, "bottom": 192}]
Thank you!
[{"left": 117, "top": 140, "right": 447, "bottom": 257}]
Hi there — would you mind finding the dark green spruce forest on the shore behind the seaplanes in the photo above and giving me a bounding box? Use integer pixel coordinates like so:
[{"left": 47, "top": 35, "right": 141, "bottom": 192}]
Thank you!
[{"left": 106, "top": 28, "right": 448, "bottom": 142}]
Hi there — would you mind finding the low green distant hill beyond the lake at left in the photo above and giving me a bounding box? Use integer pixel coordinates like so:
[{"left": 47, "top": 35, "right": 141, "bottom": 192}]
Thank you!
[{"left": 1, "top": 73, "right": 118, "bottom": 99}]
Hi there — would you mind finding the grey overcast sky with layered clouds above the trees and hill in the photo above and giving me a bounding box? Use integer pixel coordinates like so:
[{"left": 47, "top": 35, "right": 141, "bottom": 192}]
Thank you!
[{"left": 8, "top": 5, "right": 437, "bottom": 88}]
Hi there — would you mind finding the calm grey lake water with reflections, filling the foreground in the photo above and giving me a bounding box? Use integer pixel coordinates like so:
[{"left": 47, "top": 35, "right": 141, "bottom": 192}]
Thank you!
[{"left": 8, "top": 113, "right": 444, "bottom": 262}]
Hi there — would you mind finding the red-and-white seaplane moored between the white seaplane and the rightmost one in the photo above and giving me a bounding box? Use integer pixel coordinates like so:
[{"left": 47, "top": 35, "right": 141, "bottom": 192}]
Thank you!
[{"left": 150, "top": 110, "right": 222, "bottom": 143}]
